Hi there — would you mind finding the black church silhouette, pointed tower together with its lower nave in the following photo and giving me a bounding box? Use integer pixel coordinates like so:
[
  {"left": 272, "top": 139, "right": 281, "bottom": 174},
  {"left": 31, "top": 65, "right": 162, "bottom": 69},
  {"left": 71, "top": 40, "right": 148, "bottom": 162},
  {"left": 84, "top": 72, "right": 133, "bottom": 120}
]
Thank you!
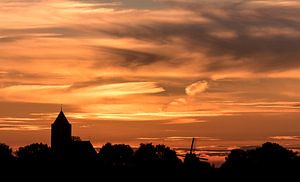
[{"left": 51, "top": 109, "right": 97, "bottom": 160}]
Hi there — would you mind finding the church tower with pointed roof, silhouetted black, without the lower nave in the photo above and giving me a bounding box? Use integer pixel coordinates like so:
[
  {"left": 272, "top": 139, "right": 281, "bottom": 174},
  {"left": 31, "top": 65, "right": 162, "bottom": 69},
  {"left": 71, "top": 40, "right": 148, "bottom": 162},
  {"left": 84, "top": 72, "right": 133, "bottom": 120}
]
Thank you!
[{"left": 51, "top": 110, "right": 72, "bottom": 156}]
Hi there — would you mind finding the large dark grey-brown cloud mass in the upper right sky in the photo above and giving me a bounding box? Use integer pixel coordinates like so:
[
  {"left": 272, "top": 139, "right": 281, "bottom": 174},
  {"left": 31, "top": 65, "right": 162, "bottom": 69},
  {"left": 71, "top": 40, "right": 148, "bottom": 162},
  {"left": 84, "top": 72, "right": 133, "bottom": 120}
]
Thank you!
[{"left": 94, "top": 1, "right": 299, "bottom": 72}]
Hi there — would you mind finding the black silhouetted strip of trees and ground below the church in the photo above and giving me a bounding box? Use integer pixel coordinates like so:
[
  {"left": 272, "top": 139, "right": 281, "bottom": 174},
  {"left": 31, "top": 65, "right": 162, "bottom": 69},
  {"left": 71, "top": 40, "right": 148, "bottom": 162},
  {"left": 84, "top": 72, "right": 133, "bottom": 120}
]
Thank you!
[{"left": 0, "top": 143, "right": 300, "bottom": 181}]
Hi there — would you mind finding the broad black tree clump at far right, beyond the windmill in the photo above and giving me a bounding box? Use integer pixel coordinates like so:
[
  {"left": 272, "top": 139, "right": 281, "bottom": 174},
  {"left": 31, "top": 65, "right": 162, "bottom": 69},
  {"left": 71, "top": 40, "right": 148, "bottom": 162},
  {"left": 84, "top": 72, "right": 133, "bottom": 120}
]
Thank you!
[{"left": 221, "top": 142, "right": 299, "bottom": 178}]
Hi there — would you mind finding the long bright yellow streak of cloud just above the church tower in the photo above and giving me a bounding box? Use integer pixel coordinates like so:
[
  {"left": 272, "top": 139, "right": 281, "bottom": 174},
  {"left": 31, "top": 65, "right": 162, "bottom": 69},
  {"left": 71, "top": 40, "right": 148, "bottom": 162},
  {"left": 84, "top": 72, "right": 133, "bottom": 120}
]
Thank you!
[{"left": 0, "top": 82, "right": 165, "bottom": 104}]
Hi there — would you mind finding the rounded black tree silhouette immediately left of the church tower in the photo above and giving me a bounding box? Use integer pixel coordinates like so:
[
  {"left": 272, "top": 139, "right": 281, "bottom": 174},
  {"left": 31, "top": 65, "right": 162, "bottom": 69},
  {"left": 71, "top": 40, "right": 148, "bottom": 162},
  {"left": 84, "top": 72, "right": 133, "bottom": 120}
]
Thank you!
[{"left": 16, "top": 143, "right": 53, "bottom": 162}]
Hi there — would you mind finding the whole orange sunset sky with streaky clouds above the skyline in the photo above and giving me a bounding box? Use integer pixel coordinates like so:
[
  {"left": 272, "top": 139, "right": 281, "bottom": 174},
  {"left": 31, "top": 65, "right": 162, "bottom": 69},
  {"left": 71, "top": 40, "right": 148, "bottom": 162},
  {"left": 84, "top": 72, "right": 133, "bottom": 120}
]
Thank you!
[{"left": 0, "top": 0, "right": 300, "bottom": 161}]
